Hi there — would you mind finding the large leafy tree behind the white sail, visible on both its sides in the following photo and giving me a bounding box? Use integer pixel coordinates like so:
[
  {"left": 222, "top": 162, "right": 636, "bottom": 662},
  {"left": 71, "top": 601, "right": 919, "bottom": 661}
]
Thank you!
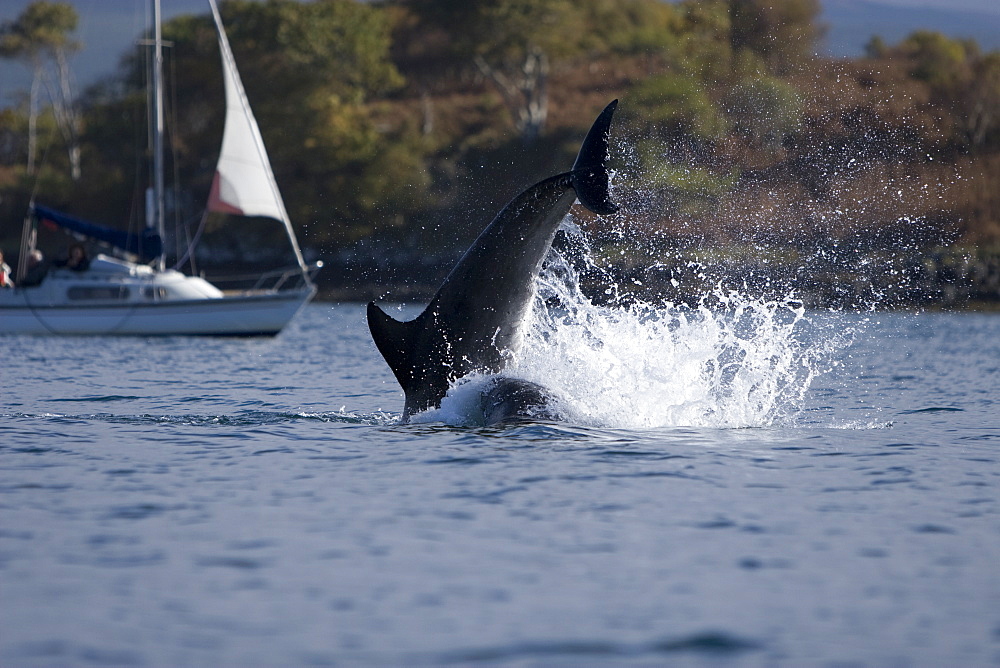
[{"left": 127, "top": 0, "right": 426, "bottom": 243}]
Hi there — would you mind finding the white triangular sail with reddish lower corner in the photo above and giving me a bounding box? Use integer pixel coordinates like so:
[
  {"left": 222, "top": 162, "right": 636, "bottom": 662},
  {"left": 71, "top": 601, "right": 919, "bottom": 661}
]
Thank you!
[{"left": 208, "top": 0, "right": 305, "bottom": 271}]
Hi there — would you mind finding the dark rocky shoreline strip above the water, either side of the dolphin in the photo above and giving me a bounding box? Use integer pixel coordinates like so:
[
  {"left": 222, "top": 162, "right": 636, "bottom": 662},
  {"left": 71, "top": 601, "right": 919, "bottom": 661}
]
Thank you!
[{"left": 316, "top": 247, "right": 1000, "bottom": 312}]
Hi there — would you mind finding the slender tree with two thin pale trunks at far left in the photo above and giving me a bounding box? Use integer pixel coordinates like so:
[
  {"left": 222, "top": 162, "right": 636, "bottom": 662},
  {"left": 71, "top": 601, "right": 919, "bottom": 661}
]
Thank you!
[{"left": 0, "top": 0, "right": 81, "bottom": 180}]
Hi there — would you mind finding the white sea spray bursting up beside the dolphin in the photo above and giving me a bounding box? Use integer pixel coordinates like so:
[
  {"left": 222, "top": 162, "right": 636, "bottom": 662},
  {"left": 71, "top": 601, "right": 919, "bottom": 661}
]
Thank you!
[{"left": 418, "top": 219, "right": 856, "bottom": 429}]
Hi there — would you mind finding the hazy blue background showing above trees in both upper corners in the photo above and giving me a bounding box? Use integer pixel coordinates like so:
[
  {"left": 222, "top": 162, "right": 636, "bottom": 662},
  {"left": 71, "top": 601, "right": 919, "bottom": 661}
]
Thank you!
[{"left": 0, "top": 0, "right": 1000, "bottom": 107}]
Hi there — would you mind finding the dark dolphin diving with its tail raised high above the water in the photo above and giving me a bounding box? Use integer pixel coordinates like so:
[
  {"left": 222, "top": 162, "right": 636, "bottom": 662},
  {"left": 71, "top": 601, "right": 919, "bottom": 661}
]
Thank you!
[{"left": 368, "top": 100, "right": 618, "bottom": 422}]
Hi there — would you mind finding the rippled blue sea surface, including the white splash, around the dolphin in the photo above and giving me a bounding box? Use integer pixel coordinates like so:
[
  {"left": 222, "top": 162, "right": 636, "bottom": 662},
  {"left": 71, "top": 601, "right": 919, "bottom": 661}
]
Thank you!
[{"left": 0, "top": 304, "right": 1000, "bottom": 667}]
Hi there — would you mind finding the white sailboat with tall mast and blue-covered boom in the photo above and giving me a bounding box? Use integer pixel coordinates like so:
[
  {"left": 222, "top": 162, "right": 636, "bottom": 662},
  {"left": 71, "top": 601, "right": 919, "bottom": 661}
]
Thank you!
[{"left": 0, "top": 0, "right": 322, "bottom": 336}]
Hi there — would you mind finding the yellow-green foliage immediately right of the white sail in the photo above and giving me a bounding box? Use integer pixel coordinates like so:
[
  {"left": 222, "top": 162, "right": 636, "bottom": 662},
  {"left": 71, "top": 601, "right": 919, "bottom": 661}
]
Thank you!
[{"left": 213, "top": 0, "right": 426, "bottom": 243}]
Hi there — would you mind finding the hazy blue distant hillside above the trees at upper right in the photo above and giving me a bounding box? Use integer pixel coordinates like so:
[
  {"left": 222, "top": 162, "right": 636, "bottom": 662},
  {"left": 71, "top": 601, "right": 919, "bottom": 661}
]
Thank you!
[{"left": 820, "top": 0, "right": 1000, "bottom": 57}]
